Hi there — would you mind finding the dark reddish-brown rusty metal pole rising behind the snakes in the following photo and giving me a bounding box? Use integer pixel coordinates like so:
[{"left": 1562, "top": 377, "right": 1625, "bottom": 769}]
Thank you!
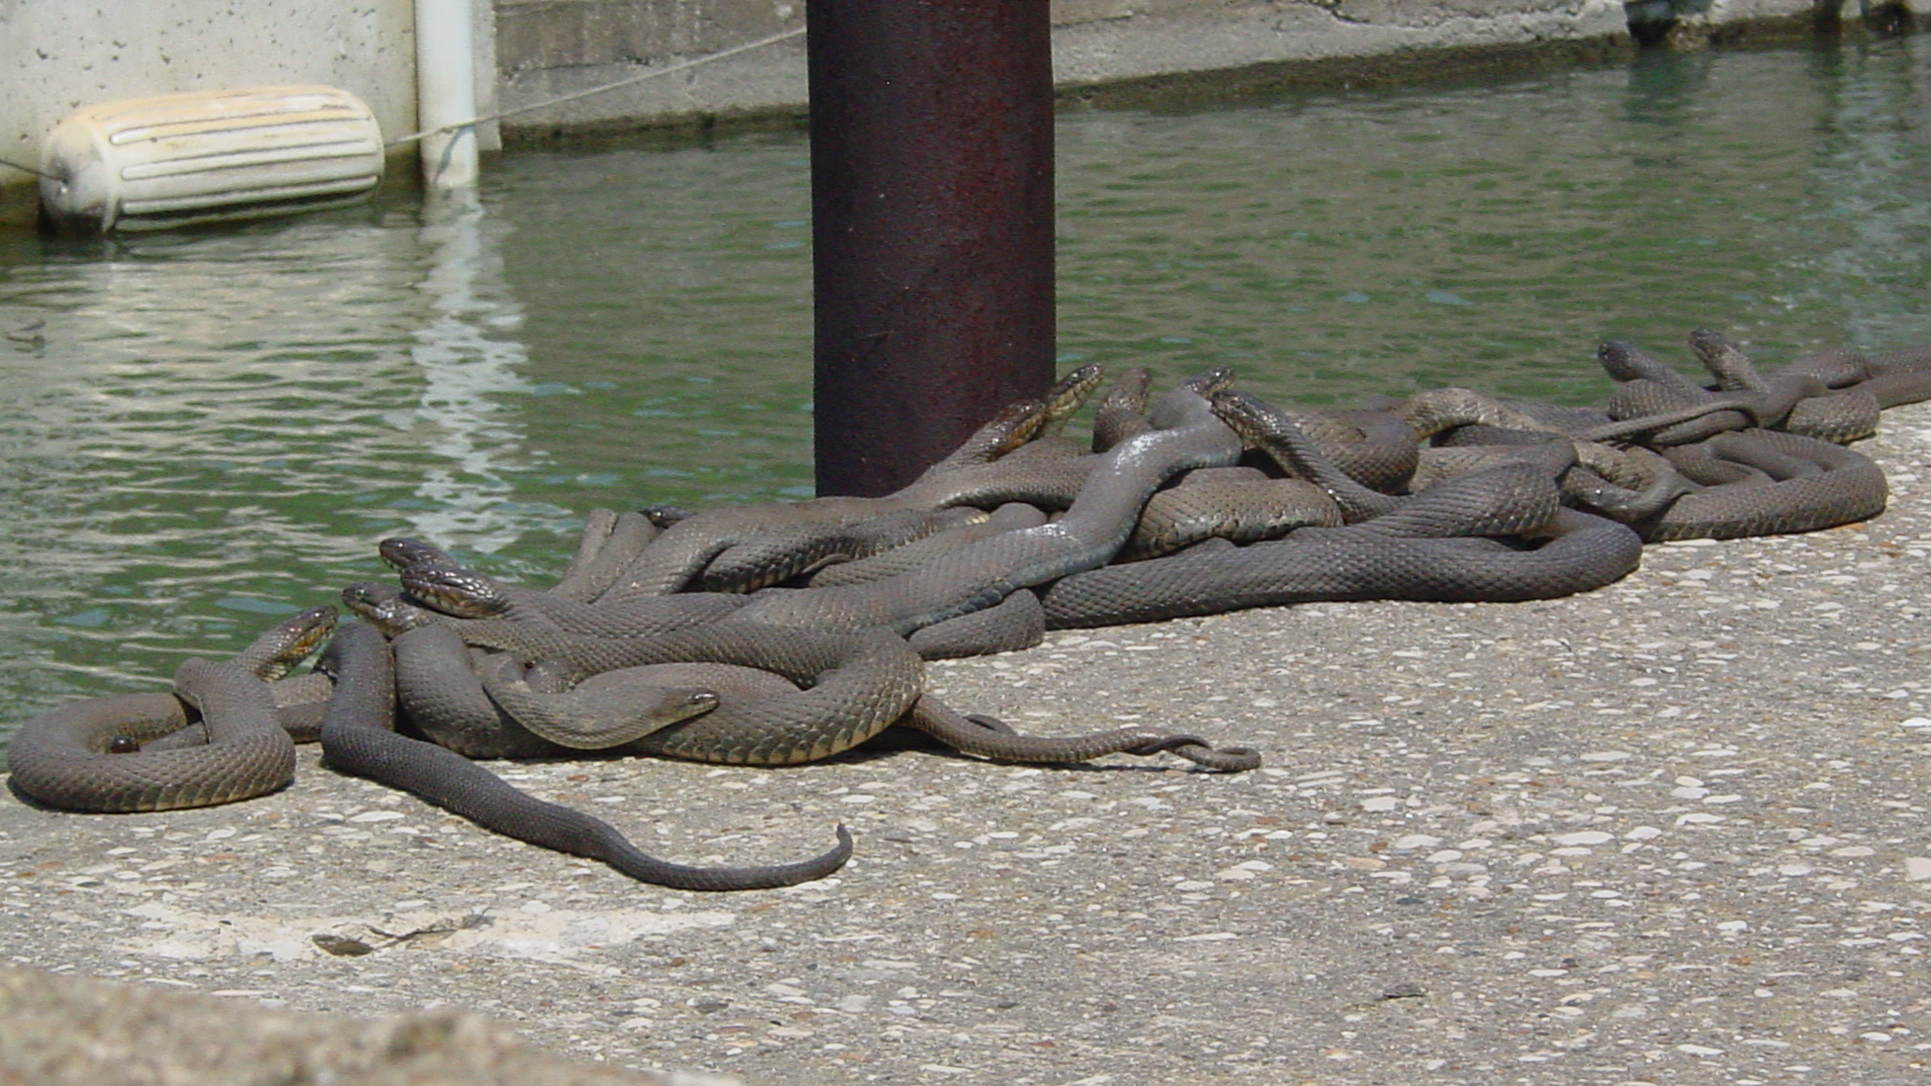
[{"left": 805, "top": 0, "right": 1054, "bottom": 495}]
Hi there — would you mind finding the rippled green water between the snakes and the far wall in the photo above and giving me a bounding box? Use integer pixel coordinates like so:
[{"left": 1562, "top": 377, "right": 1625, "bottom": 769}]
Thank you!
[{"left": 0, "top": 39, "right": 1931, "bottom": 753}]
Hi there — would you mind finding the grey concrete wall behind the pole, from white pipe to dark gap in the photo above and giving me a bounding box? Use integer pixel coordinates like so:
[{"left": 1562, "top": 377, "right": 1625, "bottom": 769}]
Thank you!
[{"left": 496, "top": 0, "right": 1628, "bottom": 141}]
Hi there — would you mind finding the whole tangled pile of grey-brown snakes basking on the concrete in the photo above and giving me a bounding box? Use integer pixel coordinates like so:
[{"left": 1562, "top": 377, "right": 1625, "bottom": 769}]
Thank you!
[{"left": 12, "top": 330, "right": 1931, "bottom": 891}]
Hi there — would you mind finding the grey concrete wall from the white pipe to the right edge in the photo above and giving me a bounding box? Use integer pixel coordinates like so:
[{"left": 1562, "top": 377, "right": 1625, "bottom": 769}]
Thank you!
[{"left": 496, "top": 0, "right": 1931, "bottom": 143}]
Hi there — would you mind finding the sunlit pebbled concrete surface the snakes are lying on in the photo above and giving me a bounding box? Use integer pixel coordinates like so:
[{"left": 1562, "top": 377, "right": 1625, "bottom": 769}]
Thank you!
[{"left": 0, "top": 408, "right": 1931, "bottom": 1086}]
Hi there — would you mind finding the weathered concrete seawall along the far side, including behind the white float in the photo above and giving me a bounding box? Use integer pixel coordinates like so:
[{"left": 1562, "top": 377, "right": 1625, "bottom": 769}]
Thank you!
[{"left": 0, "top": 0, "right": 1931, "bottom": 226}]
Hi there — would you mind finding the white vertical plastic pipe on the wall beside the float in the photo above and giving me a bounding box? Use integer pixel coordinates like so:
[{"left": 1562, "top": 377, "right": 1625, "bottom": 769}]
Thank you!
[{"left": 415, "top": 0, "right": 477, "bottom": 195}]
